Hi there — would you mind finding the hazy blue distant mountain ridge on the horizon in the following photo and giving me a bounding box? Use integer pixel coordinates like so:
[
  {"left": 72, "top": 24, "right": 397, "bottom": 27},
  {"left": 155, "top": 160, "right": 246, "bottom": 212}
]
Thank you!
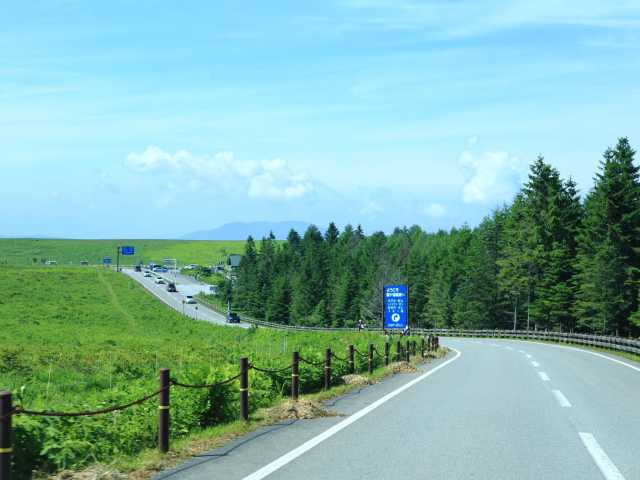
[{"left": 182, "top": 221, "right": 311, "bottom": 240}]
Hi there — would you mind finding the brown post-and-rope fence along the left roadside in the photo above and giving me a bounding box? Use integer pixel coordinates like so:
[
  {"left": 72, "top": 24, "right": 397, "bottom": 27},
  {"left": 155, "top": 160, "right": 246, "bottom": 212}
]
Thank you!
[{"left": 0, "top": 335, "right": 438, "bottom": 480}]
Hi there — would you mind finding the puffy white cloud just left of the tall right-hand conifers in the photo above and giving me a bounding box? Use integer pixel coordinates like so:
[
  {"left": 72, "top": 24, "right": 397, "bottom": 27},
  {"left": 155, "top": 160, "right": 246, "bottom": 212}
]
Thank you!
[{"left": 460, "top": 150, "right": 524, "bottom": 205}]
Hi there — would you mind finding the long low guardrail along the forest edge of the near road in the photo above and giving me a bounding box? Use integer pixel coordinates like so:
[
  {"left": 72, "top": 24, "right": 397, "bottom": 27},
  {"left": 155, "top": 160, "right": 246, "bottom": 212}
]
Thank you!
[{"left": 411, "top": 329, "right": 640, "bottom": 355}]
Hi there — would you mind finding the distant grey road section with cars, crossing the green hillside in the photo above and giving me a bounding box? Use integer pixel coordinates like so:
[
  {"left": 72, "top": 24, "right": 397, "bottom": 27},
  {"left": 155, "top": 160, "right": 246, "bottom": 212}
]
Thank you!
[{"left": 122, "top": 268, "right": 249, "bottom": 328}]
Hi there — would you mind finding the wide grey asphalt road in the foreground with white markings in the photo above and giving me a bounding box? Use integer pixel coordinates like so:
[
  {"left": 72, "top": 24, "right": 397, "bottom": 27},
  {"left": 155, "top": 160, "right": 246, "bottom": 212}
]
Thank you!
[{"left": 158, "top": 339, "right": 640, "bottom": 480}]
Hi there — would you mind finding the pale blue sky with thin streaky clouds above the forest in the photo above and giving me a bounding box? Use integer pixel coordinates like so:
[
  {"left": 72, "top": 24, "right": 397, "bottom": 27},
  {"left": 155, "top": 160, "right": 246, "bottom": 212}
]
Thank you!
[{"left": 0, "top": 0, "right": 640, "bottom": 238}]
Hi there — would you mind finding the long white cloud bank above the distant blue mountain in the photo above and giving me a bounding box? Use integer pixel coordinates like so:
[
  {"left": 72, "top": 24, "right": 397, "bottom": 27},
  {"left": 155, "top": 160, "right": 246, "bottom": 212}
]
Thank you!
[{"left": 126, "top": 146, "right": 314, "bottom": 200}]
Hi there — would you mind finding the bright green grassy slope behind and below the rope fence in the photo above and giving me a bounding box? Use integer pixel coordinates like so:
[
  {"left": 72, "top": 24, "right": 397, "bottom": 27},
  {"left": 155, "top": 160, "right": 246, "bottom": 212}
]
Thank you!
[{"left": 0, "top": 267, "right": 390, "bottom": 475}]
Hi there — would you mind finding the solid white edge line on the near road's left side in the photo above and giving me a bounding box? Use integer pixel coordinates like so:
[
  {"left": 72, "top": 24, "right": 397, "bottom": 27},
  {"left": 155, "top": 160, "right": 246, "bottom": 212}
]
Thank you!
[{"left": 243, "top": 347, "right": 462, "bottom": 480}]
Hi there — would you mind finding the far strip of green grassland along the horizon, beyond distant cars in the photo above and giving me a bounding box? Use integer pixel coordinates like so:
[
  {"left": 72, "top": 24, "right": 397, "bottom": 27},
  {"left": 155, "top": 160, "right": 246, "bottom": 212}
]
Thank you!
[{"left": 0, "top": 238, "right": 244, "bottom": 266}]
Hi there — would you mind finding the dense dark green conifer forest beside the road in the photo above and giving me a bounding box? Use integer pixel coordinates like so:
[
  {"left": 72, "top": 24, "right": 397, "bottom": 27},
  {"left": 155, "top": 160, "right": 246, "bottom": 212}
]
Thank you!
[{"left": 225, "top": 138, "right": 640, "bottom": 336}]
